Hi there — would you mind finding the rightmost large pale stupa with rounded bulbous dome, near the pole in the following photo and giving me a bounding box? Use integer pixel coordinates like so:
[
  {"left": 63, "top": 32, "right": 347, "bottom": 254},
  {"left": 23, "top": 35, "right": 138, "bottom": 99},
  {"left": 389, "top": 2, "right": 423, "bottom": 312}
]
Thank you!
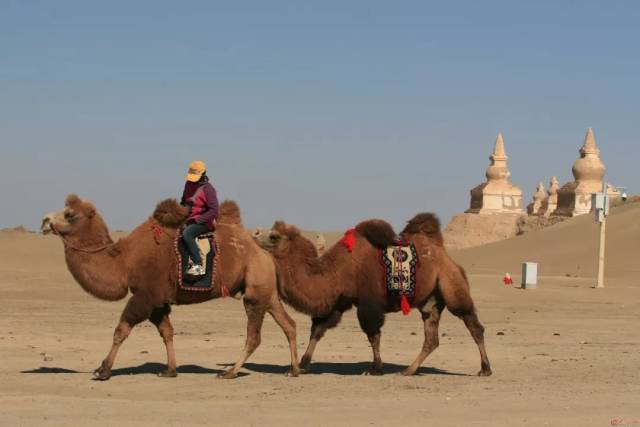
[{"left": 554, "top": 128, "right": 620, "bottom": 216}]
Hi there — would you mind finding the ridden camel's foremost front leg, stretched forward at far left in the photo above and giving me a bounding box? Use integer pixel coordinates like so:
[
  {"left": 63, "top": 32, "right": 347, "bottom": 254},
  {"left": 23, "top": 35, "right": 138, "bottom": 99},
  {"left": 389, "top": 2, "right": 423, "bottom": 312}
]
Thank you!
[{"left": 93, "top": 294, "right": 152, "bottom": 381}]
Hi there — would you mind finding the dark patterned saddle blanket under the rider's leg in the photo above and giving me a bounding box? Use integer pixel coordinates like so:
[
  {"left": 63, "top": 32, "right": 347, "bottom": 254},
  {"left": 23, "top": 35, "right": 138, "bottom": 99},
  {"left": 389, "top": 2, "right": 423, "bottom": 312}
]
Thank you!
[{"left": 175, "top": 229, "right": 220, "bottom": 291}]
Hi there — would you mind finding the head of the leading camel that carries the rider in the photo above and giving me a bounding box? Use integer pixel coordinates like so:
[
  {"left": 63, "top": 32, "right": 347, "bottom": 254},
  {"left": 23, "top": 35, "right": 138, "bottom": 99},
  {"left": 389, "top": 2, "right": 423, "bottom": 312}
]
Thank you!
[{"left": 40, "top": 194, "right": 96, "bottom": 236}]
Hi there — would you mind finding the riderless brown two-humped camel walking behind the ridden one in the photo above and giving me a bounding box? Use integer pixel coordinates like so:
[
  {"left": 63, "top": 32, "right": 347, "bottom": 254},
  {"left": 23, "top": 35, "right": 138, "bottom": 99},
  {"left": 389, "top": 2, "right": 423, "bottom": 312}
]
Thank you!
[{"left": 254, "top": 214, "right": 491, "bottom": 376}]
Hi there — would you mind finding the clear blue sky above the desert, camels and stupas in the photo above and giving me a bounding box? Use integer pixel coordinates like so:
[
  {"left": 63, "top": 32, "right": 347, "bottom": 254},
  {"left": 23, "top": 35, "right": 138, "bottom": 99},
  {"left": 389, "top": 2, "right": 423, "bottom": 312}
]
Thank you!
[{"left": 0, "top": 0, "right": 640, "bottom": 230}]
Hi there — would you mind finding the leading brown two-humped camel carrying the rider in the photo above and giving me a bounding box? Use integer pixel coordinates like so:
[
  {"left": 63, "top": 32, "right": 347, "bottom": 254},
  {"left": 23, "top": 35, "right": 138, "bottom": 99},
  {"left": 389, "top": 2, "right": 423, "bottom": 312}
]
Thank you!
[{"left": 42, "top": 195, "right": 299, "bottom": 380}]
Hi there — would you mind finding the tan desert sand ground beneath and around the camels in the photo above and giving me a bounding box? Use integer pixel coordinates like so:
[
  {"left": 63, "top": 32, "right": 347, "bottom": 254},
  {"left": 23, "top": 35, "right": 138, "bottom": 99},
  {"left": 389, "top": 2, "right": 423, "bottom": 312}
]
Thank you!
[{"left": 0, "top": 204, "right": 640, "bottom": 426}]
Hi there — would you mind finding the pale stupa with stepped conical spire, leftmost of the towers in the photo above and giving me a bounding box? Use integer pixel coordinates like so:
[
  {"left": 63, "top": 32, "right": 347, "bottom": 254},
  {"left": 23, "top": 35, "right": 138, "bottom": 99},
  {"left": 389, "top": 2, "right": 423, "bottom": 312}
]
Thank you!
[{"left": 466, "top": 133, "right": 524, "bottom": 214}]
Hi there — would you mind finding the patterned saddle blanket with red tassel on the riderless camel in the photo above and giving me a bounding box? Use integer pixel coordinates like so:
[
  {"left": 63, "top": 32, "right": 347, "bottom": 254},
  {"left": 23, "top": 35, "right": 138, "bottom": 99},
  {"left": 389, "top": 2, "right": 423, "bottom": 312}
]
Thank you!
[{"left": 380, "top": 241, "right": 419, "bottom": 298}]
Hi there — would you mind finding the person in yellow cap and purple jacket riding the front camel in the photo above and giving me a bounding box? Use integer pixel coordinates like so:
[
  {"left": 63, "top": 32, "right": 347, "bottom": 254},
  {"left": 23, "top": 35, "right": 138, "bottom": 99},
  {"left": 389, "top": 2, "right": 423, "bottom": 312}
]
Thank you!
[{"left": 180, "top": 160, "right": 218, "bottom": 276}]
